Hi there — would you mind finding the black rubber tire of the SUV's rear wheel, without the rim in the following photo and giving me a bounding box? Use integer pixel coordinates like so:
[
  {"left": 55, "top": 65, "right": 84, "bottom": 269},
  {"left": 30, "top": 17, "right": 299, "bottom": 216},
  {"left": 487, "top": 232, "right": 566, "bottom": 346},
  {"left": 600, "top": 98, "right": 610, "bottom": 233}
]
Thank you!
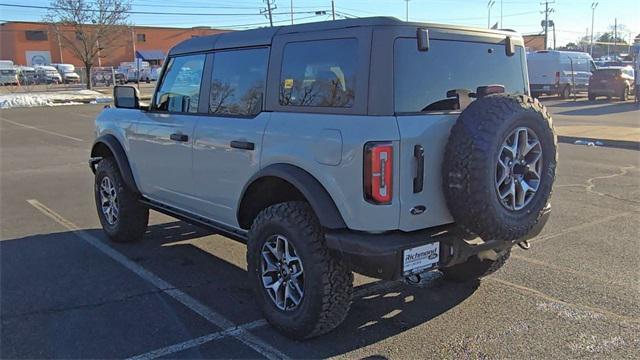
[{"left": 247, "top": 202, "right": 353, "bottom": 339}]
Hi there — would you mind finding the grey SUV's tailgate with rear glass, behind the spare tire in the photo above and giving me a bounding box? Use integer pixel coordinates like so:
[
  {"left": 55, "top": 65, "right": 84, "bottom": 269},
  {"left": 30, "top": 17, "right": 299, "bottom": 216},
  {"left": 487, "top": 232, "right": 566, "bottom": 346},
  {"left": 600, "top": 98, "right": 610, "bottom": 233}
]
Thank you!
[{"left": 393, "top": 30, "right": 528, "bottom": 231}]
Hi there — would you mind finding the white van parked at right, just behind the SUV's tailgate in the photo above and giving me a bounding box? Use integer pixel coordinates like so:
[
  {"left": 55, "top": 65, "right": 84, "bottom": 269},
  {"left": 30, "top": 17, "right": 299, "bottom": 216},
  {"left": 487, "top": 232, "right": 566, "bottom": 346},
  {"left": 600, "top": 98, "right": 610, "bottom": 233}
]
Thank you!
[{"left": 527, "top": 50, "right": 596, "bottom": 99}]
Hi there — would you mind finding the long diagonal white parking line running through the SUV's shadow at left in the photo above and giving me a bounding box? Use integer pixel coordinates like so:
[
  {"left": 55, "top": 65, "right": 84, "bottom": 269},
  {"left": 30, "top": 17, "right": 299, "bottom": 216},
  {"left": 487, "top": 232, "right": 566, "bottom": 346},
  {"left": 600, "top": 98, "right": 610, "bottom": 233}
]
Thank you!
[{"left": 27, "top": 199, "right": 287, "bottom": 359}]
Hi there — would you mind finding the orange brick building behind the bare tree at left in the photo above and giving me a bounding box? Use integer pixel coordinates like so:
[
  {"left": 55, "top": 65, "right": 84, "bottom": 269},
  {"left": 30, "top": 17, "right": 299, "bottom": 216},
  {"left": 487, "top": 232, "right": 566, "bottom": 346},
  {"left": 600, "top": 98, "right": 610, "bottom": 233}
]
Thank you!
[{"left": 0, "top": 21, "right": 226, "bottom": 66}]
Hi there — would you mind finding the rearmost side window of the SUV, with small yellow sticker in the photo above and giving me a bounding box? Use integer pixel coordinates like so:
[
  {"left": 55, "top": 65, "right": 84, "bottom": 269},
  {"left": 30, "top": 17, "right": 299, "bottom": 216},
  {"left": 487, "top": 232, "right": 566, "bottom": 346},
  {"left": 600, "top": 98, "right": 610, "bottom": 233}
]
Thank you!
[{"left": 280, "top": 39, "right": 358, "bottom": 107}]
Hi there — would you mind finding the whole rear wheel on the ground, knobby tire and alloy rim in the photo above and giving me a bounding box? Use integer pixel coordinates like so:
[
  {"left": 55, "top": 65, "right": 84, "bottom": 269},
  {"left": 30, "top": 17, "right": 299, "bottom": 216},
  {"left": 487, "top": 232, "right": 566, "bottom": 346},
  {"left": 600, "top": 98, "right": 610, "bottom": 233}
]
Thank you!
[{"left": 247, "top": 202, "right": 353, "bottom": 339}]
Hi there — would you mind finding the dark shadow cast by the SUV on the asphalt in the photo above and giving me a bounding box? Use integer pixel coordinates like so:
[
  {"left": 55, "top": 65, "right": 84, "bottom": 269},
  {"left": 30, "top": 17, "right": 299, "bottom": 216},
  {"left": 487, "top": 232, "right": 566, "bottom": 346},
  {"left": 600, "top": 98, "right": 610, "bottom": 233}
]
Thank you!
[{"left": 0, "top": 221, "right": 478, "bottom": 358}]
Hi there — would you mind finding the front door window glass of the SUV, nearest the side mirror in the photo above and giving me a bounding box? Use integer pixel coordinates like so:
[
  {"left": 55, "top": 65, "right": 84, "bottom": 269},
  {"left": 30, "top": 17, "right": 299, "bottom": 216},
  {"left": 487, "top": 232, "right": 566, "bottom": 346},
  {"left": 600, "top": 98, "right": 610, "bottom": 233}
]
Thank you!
[{"left": 154, "top": 54, "right": 206, "bottom": 113}]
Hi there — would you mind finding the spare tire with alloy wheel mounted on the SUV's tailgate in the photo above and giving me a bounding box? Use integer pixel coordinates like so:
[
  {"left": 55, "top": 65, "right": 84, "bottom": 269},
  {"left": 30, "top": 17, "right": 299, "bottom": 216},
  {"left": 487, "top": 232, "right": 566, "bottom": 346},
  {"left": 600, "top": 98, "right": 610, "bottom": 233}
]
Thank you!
[{"left": 442, "top": 94, "right": 557, "bottom": 241}]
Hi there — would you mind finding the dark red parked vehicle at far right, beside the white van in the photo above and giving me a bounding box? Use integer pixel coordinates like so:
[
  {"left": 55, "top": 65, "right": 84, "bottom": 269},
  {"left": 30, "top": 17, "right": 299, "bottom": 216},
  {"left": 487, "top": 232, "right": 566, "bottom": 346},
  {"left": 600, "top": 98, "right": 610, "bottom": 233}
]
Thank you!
[{"left": 589, "top": 66, "right": 635, "bottom": 101}]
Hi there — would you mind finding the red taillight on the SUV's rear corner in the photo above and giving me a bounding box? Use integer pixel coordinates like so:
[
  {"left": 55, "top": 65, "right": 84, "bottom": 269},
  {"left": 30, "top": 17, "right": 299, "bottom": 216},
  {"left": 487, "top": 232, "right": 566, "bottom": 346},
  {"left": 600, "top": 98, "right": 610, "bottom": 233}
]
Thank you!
[{"left": 364, "top": 142, "right": 393, "bottom": 204}]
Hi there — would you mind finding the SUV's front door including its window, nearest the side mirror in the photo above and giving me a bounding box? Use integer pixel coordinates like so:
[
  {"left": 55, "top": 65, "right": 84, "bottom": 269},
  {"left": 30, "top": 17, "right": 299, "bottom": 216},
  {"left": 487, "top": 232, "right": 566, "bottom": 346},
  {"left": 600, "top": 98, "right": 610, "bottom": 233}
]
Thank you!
[{"left": 125, "top": 54, "right": 206, "bottom": 210}]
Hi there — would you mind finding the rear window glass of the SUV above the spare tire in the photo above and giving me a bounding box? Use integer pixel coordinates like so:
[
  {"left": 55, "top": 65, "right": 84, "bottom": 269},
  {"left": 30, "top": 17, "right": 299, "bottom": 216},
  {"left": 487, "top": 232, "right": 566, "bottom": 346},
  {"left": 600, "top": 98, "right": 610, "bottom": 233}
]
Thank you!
[{"left": 394, "top": 38, "right": 527, "bottom": 113}]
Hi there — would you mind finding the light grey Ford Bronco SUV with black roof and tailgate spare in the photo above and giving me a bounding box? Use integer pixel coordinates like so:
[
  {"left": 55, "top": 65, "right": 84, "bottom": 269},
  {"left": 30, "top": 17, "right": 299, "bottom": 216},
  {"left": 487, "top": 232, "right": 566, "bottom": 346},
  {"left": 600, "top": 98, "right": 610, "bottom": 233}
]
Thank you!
[{"left": 90, "top": 17, "right": 557, "bottom": 339}]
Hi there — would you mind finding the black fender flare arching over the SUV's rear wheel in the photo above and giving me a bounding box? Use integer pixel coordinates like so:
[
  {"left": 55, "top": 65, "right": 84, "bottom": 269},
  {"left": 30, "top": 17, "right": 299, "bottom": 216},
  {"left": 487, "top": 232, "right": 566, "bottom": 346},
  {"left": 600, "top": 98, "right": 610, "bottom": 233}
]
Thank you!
[{"left": 236, "top": 164, "right": 347, "bottom": 229}]
